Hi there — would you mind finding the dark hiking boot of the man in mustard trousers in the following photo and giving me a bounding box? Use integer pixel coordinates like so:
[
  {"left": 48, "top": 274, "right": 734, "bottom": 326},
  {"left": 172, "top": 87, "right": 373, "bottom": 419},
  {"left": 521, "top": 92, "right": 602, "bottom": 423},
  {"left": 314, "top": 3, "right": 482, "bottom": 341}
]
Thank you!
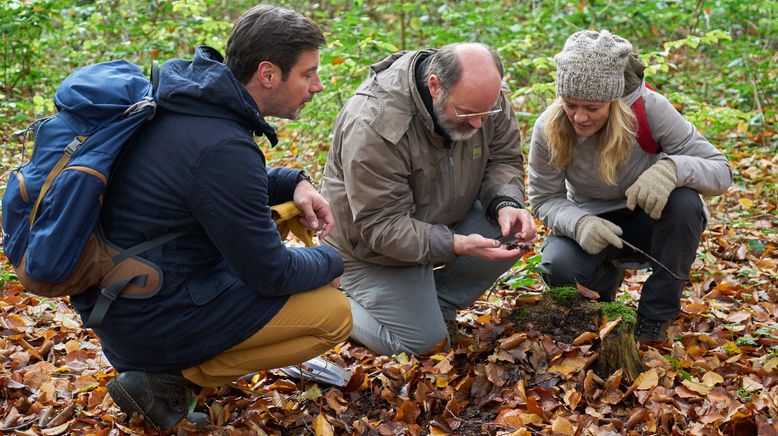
[{"left": 106, "top": 371, "right": 211, "bottom": 430}]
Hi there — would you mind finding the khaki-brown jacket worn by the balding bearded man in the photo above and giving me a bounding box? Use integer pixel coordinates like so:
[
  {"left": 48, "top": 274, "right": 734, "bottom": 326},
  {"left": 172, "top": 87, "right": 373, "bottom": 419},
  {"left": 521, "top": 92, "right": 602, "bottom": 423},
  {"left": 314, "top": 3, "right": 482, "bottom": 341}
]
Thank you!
[{"left": 322, "top": 50, "right": 524, "bottom": 266}]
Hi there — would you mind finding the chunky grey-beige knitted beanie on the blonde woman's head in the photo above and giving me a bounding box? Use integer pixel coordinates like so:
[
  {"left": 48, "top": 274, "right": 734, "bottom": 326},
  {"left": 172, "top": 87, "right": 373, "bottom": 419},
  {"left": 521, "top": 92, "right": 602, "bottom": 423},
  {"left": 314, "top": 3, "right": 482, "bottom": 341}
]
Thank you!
[{"left": 554, "top": 30, "right": 632, "bottom": 101}]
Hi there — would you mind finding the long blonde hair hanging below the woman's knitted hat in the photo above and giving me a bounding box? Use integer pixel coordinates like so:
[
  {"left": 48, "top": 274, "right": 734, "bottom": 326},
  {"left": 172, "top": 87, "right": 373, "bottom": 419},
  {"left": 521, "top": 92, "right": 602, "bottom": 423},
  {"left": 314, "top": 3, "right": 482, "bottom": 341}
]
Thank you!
[{"left": 543, "top": 98, "right": 636, "bottom": 185}]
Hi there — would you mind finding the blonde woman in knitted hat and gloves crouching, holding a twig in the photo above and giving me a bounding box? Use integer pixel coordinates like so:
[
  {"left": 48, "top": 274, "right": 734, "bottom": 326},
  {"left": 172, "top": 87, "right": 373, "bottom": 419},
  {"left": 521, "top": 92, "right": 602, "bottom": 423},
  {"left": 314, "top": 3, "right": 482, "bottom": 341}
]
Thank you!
[{"left": 528, "top": 30, "right": 732, "bottom": 342}]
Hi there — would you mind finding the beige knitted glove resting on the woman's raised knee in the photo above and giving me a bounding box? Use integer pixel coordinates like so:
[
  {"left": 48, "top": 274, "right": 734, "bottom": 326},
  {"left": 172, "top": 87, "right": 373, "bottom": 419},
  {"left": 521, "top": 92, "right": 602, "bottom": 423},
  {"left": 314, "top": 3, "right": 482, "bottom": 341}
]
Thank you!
[{"left": 626, "top": 159, "right": 678, "bottom": 220}]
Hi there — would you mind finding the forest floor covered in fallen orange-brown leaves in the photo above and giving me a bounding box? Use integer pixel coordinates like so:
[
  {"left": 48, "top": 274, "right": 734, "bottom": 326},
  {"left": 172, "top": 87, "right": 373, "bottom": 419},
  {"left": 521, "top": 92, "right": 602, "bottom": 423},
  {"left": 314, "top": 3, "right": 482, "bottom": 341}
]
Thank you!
[{"left": 0, "top": 155, "right": 778, "bottom": 435}]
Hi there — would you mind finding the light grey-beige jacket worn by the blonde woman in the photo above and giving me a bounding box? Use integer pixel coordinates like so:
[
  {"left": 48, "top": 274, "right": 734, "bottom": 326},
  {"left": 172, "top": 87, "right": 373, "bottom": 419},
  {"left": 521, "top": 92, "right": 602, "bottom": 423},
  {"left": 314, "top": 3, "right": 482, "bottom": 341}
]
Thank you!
[{"left": 528, "top": 80, "right": 732, "bottom": 239}]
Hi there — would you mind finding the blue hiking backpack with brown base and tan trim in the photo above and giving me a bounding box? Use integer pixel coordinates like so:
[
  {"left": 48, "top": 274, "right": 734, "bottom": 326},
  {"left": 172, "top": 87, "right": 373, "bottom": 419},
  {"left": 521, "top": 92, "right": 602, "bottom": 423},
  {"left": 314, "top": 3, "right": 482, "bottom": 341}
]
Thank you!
[{"left": 2, "top": 60, "right": 180, "bottom": 326}]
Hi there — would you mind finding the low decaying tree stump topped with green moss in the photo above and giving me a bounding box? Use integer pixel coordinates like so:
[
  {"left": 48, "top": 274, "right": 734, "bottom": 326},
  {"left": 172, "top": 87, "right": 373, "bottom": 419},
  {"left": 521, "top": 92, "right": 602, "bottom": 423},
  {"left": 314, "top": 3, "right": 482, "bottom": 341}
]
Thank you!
[{"left": 511, "top": 287, "right": 644, "bottom": 383}]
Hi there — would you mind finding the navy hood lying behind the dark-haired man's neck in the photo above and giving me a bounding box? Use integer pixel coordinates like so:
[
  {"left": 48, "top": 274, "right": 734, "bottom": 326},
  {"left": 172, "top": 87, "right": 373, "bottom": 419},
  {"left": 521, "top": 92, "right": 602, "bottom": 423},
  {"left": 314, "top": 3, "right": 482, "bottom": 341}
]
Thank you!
[{"left": 154, "top": 45, "right": 278, "bottom": 145}]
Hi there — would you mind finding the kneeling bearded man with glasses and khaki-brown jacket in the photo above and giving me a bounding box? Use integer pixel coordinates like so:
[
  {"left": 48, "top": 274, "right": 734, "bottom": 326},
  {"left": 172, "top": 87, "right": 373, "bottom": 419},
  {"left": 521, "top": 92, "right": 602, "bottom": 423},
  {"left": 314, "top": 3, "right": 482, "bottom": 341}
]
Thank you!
[{"left": 322, "top": 43, "right": 536, "bottom": 354}]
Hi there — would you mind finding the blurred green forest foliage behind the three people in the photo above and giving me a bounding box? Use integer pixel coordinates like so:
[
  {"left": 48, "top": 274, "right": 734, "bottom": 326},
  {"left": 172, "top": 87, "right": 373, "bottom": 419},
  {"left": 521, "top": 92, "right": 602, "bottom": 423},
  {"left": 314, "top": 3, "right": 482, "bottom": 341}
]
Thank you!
[{"left": 0, "top": 0, "right": 778, "bottom": 174}]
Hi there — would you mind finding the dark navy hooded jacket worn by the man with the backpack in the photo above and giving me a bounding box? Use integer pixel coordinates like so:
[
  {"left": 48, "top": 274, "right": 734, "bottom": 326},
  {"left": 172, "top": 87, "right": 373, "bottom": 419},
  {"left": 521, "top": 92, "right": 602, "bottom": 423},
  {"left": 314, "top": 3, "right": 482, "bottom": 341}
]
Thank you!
[{"left": 71, "top": 47, "right": 343, "bottom": 371}]
